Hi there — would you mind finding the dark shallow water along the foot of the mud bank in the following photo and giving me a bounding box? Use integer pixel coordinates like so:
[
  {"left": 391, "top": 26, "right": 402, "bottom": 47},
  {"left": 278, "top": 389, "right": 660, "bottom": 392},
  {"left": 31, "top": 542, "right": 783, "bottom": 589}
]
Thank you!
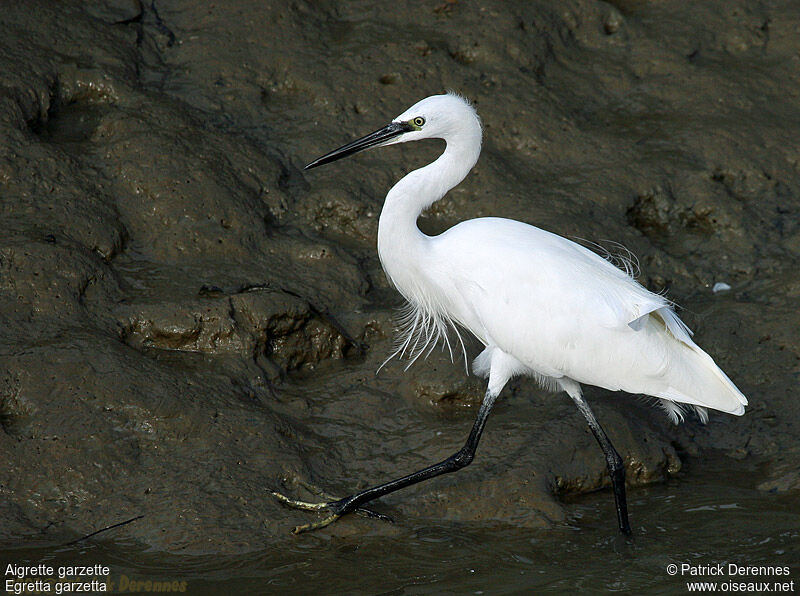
[{"left": 0, "top": 457, "right": 800, "bottom": 594}]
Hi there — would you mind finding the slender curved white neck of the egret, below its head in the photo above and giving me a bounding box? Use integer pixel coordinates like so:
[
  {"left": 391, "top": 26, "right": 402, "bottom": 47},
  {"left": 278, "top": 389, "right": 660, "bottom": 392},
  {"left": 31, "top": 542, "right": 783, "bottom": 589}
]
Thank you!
[{"left": 378, "top": 126, "right": 481, "bottom": 300}]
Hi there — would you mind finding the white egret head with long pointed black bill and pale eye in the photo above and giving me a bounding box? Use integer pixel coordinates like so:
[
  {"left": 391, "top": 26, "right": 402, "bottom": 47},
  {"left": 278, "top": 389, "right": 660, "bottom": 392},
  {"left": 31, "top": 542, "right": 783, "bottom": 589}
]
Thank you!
[{"left": 305, "top": 93, "right": 481, "bottom": 170}]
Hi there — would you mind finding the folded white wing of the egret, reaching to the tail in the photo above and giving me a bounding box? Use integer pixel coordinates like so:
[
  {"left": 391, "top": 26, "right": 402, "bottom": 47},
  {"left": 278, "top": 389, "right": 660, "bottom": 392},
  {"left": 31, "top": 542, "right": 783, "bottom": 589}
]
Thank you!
[{"left": 426, "top": 218, "right": 747, "bottom": 414}]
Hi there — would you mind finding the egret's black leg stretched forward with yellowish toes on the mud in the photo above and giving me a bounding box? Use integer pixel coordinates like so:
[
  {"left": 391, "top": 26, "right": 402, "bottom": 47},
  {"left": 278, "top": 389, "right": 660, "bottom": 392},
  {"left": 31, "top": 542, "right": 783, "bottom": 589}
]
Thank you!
[{"left": 272, "top": 390, "right": 497, "bottom": 534}]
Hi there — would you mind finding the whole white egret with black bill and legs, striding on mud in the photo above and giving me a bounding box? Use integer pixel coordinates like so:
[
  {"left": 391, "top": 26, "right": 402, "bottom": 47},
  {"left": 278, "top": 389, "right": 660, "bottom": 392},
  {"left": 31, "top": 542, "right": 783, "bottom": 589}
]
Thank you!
[{"left": 273, "top": 93, "right": 747, "bottom": 534}]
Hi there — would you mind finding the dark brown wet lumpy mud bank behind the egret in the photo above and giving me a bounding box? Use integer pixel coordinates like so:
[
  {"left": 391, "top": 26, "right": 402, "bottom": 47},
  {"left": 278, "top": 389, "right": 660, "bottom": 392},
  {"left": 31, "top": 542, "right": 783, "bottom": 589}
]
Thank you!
[{"left": 0, "top": 0, "right": 800, "bottom": 591}]
